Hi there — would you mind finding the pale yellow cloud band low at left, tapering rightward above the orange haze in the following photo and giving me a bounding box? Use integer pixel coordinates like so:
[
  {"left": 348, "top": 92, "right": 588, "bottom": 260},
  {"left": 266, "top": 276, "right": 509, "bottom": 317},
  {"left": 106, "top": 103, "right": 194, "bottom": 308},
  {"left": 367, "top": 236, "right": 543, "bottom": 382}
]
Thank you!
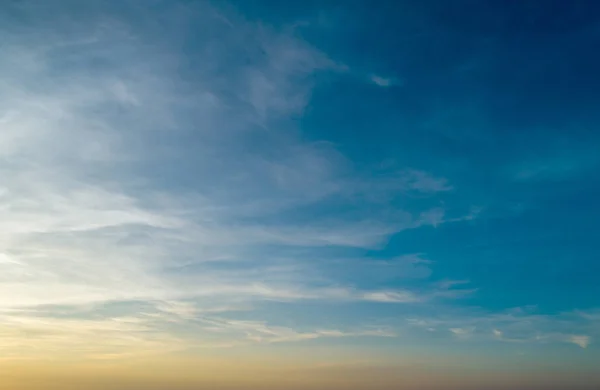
[{"left": 0, "top": 301, "right": 396, "bottom": 359}]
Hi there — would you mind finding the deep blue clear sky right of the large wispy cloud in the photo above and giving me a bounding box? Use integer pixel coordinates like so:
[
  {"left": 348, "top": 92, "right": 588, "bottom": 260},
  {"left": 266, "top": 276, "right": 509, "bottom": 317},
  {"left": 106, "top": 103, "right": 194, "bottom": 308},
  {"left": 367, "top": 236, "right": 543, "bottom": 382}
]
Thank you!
[{"left": 224, "top": 1, "right": 600, "bottom": 312}]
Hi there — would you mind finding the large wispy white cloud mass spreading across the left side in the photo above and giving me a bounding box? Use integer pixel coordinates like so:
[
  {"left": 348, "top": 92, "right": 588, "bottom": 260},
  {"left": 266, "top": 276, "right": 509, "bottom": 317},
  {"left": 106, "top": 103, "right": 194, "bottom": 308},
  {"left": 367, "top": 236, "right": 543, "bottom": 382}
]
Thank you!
[{"left": 0, "top": 2, "right": 468, "bottom": 356}]
